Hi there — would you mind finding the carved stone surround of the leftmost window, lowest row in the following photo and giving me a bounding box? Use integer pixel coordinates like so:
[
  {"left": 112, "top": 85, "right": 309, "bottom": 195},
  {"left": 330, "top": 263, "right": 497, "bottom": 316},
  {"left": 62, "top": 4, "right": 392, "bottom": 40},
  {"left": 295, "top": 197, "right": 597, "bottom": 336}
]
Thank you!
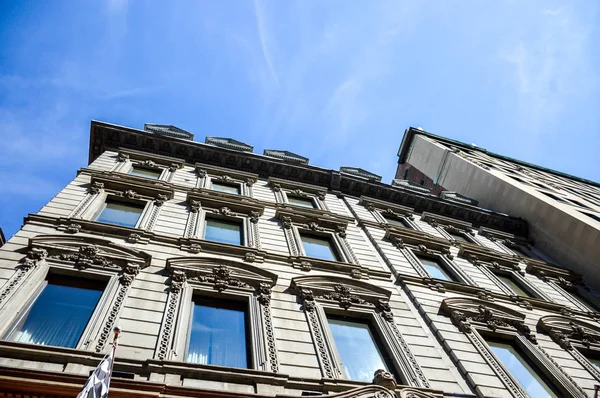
[{"left": 0, "top": 235, "right": 150, "bottom": 352}]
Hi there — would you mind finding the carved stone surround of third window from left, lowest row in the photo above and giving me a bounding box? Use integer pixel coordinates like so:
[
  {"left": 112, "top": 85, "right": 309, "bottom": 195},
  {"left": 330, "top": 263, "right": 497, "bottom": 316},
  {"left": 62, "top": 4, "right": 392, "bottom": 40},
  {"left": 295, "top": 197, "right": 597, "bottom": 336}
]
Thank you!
[{"left": 290, "top": 276, "right": 430, "bottom": 388}]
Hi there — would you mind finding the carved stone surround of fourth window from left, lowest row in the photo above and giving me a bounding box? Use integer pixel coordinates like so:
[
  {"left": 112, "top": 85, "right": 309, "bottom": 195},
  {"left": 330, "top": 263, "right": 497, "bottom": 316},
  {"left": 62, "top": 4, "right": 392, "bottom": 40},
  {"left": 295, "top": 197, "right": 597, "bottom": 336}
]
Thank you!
[{"left": 440, "top": 297, "right": 587, "bottom": 398}]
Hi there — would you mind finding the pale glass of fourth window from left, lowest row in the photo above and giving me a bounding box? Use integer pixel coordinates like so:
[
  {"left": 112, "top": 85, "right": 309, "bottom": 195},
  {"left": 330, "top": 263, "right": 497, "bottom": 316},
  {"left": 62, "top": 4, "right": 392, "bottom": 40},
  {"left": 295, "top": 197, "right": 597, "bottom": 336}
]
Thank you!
[{"left": 488, "top": 341, "right": 558, "bottom": 398}]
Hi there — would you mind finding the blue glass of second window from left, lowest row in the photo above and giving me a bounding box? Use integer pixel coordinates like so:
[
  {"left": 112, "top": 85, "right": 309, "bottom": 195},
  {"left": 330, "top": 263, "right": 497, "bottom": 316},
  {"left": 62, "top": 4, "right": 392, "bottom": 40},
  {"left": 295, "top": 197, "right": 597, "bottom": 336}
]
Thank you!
[{"left": 187, "top": 304, "right": 248, "bottom": 368}]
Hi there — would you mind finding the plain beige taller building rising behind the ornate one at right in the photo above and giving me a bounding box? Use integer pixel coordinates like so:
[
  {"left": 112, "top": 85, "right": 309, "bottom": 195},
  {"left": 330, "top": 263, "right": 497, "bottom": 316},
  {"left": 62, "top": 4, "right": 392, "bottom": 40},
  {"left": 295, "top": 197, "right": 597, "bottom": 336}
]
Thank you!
[{"left": 396, "top": 128, "right": 600, "bottom": 288}]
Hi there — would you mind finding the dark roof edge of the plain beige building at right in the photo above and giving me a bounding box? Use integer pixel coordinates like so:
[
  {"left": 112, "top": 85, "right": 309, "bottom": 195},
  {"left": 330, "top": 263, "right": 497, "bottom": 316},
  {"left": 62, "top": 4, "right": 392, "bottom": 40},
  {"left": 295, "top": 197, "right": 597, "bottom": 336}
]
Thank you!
[{"left": 398, "top": 127, "right": 600, "bottom": 187}]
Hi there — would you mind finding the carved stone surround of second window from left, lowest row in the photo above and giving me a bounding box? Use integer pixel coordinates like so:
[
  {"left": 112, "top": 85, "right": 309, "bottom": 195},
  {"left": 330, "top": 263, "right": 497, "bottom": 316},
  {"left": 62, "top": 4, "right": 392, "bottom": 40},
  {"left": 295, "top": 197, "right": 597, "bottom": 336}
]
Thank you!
[{"left": 154, "top": 257, "right": 279, "bottom": 373}]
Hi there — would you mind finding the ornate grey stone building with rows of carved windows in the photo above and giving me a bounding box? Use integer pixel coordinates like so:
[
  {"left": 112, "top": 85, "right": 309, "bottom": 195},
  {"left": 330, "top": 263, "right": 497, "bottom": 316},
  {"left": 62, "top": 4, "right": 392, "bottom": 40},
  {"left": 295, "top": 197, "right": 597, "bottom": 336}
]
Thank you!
[{"left": 0, "top": 122, "right": 600, "bottom": 398}]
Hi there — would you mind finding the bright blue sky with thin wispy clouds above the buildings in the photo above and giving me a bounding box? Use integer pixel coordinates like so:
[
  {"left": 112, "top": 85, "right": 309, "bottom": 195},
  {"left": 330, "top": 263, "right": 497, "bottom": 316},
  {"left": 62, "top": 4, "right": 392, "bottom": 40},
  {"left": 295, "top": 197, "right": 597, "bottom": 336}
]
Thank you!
[{"left": 0, "top": 0, "right": 600, "bottom": 236}]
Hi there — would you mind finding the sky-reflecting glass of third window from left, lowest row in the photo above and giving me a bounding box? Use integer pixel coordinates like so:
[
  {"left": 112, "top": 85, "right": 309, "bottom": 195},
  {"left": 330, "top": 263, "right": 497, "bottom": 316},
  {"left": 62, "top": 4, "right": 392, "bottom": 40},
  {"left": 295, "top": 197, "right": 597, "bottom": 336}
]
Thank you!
[{"left": 328, "top": 319, "right": 389, "bottom": 383}]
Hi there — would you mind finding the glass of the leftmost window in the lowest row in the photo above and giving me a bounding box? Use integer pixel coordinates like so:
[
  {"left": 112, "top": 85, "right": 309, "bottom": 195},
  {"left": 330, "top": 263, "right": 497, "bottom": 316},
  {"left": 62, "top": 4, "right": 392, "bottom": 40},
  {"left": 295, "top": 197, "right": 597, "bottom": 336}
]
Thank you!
[{"left": 7, "top": 275, "right": 105, "bottom": 348}]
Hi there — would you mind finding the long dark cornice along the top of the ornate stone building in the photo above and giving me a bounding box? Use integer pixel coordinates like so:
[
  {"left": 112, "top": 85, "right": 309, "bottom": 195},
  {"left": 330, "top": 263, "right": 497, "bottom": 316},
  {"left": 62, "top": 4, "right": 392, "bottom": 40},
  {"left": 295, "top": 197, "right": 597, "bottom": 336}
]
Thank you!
[{"left": 89, "top": 121, "right": 528, "bottom": 236}]
